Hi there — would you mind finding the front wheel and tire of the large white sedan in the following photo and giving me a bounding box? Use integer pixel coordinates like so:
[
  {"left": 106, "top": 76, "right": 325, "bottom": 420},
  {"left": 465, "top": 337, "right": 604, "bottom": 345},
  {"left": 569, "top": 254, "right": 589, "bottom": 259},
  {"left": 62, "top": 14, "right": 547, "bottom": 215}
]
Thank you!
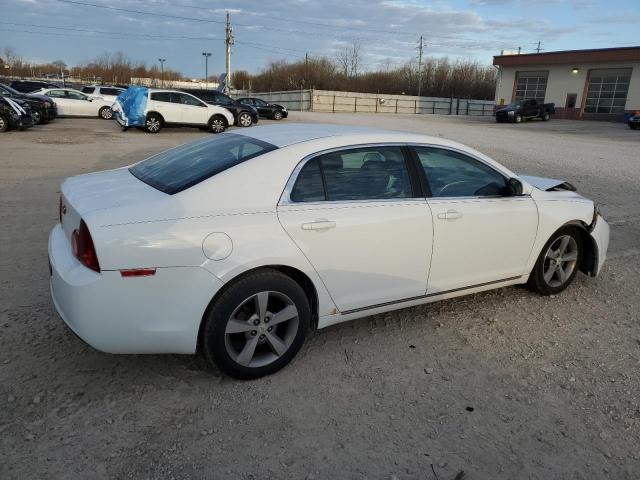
[{"left": 527, "top": 227, "right": 583, "bottom": 295}]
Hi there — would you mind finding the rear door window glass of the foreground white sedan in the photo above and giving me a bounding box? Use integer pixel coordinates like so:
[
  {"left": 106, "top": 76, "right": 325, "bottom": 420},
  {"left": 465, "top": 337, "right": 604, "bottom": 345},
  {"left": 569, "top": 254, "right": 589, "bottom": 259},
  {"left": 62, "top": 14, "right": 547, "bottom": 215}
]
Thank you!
[{"left": 291, "top": 146, "right": 413, "bottom": 202}]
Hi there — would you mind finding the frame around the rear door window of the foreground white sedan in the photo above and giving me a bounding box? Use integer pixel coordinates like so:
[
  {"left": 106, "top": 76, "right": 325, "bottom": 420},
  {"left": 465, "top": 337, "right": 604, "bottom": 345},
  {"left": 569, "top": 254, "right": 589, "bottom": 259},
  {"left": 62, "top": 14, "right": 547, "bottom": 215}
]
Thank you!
[{"left": 278, "top": 142, "right": 425, "bottom": 206}]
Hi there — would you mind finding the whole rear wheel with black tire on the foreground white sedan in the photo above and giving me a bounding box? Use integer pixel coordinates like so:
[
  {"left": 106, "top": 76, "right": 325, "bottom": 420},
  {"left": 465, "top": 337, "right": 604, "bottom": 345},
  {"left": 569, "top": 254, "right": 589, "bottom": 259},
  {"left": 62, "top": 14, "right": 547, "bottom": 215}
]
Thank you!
[{"left": 202, "top": 270, "right": 311, "bottom": 380}]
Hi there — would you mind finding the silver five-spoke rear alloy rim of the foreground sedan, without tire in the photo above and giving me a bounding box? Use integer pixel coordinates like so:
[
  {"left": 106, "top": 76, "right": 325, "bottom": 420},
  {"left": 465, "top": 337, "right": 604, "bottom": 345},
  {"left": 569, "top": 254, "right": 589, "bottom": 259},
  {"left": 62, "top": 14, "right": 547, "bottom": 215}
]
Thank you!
[{"left": 224, "top": 291, "right": 299, "bottom": 368}]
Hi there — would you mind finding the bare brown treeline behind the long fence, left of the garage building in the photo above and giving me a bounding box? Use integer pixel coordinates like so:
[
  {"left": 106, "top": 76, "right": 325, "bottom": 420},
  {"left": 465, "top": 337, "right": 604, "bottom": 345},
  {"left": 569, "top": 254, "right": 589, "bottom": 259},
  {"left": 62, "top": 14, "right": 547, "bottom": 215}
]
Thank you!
[{"left": 232, "top": 57, "right": 496, "bottom": 100}]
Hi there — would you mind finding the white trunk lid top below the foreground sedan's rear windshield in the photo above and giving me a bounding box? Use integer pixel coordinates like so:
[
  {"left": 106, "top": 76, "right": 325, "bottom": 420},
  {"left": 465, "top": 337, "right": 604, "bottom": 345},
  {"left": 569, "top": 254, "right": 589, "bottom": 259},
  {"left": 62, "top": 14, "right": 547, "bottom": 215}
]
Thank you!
[{"left": 61, "top": 168, "right": 167, "bottom": 215}]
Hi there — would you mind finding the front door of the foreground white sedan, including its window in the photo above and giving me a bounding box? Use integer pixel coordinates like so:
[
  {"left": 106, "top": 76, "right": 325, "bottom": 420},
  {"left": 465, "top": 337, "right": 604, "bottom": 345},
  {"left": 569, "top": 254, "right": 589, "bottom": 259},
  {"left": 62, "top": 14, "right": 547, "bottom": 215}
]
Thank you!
[{"left": 408, "top": 147, "right": 538, "bottom": 294}]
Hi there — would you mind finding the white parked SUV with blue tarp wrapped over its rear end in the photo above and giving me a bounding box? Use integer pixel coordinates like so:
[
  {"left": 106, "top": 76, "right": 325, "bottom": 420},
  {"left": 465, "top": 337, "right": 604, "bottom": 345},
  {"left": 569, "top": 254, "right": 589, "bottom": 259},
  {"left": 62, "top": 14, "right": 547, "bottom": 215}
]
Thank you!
[{"left": 113, "top": 88, "right": 234, "bottom": 133}]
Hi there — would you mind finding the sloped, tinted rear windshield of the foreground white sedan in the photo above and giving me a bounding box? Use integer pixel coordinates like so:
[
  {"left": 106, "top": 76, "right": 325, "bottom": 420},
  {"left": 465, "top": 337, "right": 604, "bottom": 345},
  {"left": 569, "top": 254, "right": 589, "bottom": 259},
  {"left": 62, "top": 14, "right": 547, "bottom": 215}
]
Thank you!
[{"left": 129, "top": 133, "right": 277, "bottom": 195}]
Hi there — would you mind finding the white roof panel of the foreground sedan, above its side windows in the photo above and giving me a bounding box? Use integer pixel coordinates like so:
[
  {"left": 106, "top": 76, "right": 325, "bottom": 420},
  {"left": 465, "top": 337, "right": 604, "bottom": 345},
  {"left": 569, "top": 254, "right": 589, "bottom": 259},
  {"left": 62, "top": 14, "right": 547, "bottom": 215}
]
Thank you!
[{"left": 235, "top": 123, "right": 459, "bottom": 148}]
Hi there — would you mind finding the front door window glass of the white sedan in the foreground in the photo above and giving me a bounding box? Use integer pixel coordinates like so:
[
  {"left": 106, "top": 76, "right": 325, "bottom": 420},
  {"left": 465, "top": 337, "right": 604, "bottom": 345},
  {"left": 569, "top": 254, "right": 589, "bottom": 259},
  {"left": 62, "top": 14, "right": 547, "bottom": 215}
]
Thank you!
[{"left": 415, "top": 147, "right": 507, "bottom": 197}]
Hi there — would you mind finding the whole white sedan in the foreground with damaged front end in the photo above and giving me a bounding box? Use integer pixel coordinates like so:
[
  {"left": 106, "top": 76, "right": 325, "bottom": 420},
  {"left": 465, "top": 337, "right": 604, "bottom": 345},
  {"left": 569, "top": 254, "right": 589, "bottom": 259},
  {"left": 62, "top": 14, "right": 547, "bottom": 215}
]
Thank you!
[{"left": 49, "top": 124, "right": 609, "bottom": 378}]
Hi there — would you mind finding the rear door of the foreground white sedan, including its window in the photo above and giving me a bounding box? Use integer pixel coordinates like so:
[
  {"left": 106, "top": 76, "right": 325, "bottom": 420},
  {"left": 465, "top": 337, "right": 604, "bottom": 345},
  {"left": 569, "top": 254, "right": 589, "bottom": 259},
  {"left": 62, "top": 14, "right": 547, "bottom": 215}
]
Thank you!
[{"left": 278, "top": 146, "right": 432, "bottom": 313}]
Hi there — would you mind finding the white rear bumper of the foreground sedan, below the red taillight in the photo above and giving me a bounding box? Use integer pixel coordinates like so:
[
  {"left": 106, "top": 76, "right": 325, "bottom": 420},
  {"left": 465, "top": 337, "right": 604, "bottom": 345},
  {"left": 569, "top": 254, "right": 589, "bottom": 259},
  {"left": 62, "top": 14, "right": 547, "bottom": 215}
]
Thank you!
[{"left": 49, "top": 224, "right": 222, "bottom": 353}]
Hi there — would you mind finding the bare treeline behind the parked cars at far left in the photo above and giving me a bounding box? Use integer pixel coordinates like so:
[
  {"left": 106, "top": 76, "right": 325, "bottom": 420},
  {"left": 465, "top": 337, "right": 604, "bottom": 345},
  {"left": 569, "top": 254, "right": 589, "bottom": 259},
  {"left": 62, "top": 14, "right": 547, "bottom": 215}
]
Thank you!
[{"left": 0, "top": 48, "right": 183, "bottom": 84}]
